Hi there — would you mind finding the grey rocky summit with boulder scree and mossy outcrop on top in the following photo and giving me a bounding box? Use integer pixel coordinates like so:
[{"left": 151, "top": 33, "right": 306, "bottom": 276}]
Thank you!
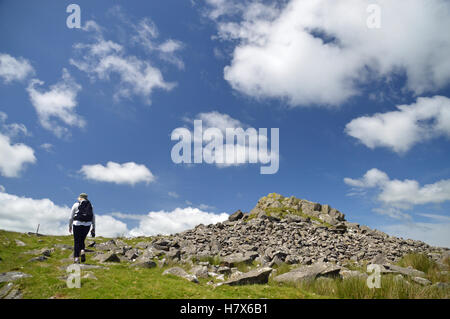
[{"left": 163, "top": 193, "right": 448, "bottom": 267}]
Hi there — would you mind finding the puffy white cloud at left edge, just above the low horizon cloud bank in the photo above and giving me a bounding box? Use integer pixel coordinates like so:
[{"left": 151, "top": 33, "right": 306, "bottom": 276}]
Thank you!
[{"left": 0, "top": 133, "right": 36, "bottom": 177}]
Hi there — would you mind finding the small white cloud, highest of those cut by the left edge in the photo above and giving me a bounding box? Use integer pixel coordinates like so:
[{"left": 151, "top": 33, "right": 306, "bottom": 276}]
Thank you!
[{"left": 0, "top": 53, "right": 34, "bottom": 83}]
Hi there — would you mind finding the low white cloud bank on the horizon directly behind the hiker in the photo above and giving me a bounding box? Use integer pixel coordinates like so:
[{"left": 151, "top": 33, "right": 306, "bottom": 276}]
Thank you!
[{"left": 0, "top": 192, "right": 128, "bottom": 237}]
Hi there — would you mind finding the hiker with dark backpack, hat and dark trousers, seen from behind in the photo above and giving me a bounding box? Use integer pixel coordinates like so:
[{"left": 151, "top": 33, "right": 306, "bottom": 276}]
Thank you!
[{"left": 69, "top": 193, "right": 95, "bottom": 264}]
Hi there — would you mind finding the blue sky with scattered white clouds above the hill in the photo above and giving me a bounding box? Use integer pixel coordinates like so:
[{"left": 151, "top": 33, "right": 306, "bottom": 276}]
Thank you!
[{"left": 0, "top": 0, "right": 450, "bottom": 247}]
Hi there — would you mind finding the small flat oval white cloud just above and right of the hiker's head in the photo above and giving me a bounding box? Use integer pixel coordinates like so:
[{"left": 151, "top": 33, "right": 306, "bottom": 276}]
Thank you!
[{"left": 80, "top": 162, "right": 155, "bottom": 185}]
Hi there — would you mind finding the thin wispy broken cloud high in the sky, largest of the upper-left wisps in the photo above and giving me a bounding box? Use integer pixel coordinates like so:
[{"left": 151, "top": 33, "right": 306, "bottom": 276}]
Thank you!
[{"left": 70, "top": 19, "right": 178, "bottom": 104}]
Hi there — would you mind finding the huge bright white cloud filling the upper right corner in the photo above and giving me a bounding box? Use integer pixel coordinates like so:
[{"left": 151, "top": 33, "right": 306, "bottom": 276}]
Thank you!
[{"left": 207, "top": 0, "right": 450, "bottom": 106}]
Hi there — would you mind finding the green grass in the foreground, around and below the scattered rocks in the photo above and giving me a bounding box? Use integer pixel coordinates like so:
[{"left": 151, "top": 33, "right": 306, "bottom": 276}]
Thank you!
[{"left": 0, "top": 230, "right": 450, "bottom": 299}]
